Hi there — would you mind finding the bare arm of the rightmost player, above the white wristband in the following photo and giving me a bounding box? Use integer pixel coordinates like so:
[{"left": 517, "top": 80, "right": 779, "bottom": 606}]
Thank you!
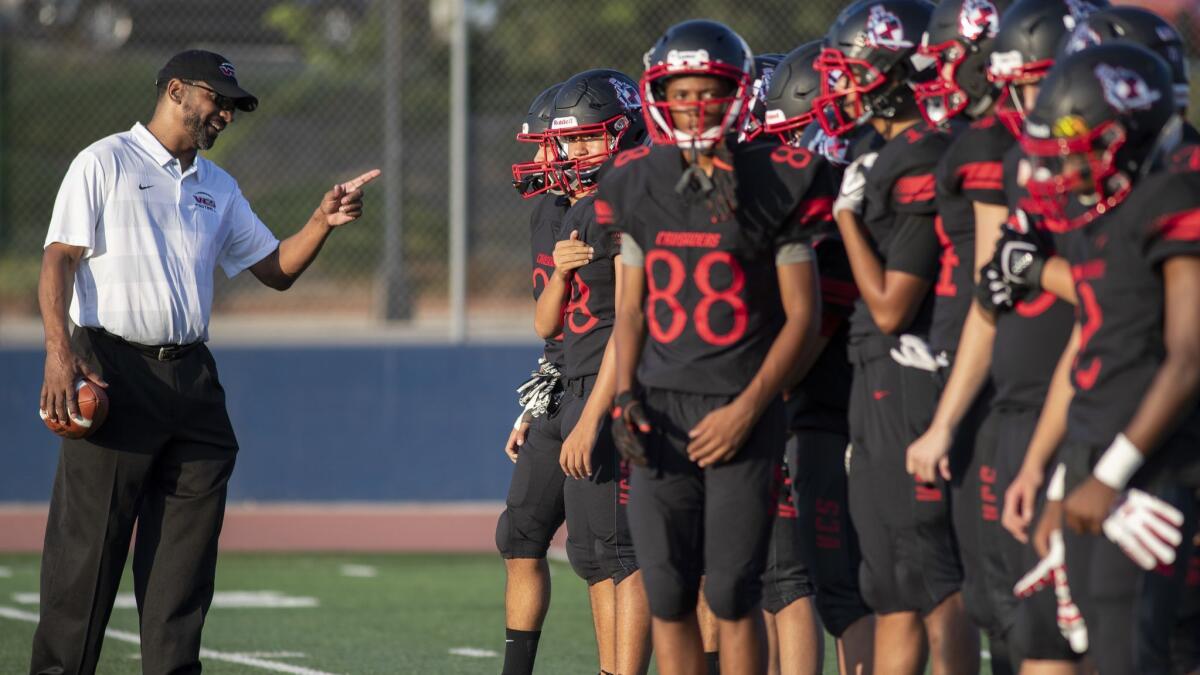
[{"left": 1124, "top": 257, "right": 1200, "bottom": 455}]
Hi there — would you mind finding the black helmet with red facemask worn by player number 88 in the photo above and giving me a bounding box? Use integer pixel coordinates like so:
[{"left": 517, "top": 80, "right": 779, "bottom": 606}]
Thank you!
[{"left": 641, "top": 19, "right": 754, "bottom": 150}]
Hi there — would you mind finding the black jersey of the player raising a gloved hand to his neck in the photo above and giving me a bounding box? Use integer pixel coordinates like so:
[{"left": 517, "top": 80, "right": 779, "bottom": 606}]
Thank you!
[{"left": 850, "top": 121, "right": 954, "bottom": 342}]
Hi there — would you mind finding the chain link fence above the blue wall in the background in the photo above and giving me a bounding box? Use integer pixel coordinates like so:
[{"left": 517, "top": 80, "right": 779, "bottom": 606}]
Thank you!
[{"left": 0, "top": 0, "right": 1200, "bottom": 338}]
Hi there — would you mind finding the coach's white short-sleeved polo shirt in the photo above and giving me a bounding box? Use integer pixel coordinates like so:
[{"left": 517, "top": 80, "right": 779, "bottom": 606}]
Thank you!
[{"left": 46, "top": 124, "right": 280, "bottom": 345}]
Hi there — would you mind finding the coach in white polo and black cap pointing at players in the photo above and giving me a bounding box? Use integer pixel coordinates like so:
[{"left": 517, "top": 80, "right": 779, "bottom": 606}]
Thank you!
[{"left": 30, "top": 50, "right": 379, "bottom": 675}]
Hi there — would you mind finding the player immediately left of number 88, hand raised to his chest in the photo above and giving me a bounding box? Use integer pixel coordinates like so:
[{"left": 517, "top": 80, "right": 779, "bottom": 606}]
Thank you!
[{"left": 535, "top": 68, "right": 649, "bottom": 673}]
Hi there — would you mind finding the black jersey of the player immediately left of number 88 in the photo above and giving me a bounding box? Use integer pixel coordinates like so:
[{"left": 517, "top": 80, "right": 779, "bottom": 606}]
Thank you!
[{"left": 558, "top": 196, "right": 620, "bottom": 380}]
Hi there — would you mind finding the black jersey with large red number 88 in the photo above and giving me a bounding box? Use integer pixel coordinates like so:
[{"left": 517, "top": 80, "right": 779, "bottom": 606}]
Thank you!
[{"left": 596, "top": 138, "right": 834, "bottom": 395}]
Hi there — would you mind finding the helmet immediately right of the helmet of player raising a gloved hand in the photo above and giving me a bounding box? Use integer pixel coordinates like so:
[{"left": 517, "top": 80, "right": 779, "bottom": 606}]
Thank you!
[{"left": 913, "top": 0, "right": 1013, "bottom": 125}]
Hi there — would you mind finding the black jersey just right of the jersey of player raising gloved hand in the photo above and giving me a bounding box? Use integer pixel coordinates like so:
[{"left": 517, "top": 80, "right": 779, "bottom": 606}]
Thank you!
[{"left": 929, "top": 115, "right": 1016, "bottom": 353}]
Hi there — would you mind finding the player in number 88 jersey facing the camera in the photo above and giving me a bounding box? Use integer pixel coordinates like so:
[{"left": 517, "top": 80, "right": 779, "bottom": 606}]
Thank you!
[{"left": 596, "top": 20, "right": 832, "bottom": 673}]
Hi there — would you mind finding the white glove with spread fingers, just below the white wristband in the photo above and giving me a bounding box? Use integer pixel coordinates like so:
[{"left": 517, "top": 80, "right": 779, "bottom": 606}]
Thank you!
[{"left": 1104, "top": 489, "right": 1183, "bottom": 571}]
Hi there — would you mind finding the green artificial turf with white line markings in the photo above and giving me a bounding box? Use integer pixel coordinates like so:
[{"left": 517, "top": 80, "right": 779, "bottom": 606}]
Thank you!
[{"left": 0, "top": 554, "right": 990, "bottom": 675}]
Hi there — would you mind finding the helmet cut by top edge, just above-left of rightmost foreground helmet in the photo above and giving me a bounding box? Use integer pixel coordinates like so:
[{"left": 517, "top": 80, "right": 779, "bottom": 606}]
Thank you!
[{"left": 988, "top": 0, "right": 1109, "bottom": 137}]
